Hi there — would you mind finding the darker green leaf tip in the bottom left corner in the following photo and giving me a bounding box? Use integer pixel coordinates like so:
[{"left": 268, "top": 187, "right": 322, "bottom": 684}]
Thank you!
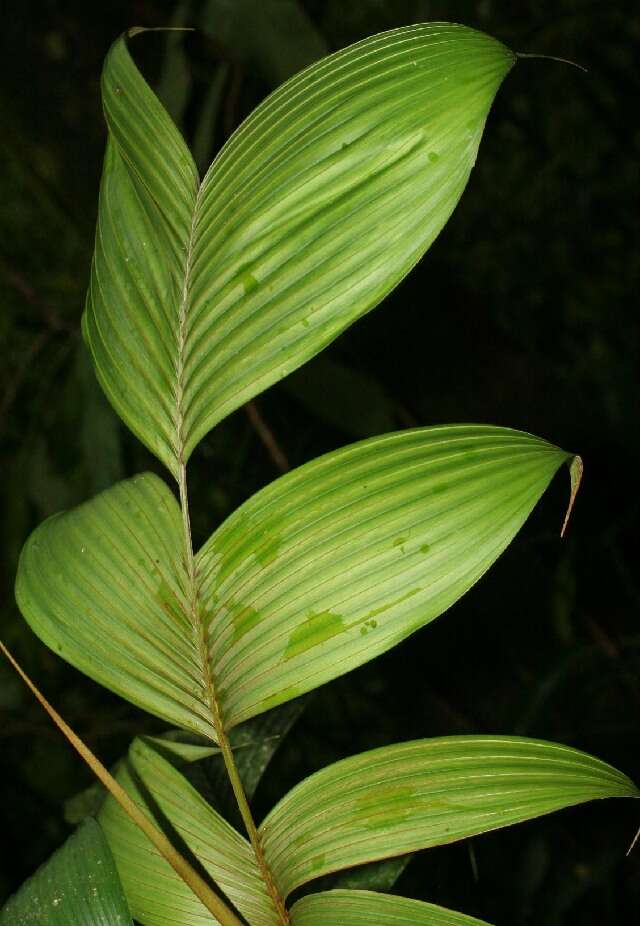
[{"left": 0, "top": 819, "right": 132, "bottom": 926}]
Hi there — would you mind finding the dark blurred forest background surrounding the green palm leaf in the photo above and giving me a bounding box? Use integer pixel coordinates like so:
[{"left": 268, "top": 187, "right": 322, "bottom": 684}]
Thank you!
[{"left": 0, "top": 0, "right": 640, "bottom": 926}]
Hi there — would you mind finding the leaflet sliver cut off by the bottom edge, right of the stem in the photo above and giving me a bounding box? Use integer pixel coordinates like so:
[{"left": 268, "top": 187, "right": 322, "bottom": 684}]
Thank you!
[{"left": 291, "top": 891, "right": 488, "bottom": 926}]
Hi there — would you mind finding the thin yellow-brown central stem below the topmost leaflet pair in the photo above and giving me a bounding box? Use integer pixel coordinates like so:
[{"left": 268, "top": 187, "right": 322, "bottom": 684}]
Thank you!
[{"left": 178, "top": 461, "right": 291, "bottom": 926}]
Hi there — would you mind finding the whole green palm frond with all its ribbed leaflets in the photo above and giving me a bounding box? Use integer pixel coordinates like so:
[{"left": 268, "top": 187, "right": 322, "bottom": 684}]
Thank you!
[{"left": 0, "top": 24, "right": 638, "bottom": 926}]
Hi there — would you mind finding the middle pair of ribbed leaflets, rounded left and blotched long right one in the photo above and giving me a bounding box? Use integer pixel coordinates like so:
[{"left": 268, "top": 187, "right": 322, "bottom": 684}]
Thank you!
[{"left": 16, "top": 425, "right": 570, "bottom": 740}]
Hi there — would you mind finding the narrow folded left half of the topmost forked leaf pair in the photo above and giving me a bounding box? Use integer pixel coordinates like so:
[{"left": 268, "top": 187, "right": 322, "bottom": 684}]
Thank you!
[{"left": 82, "top": 37, "right": 199, "bottom": 475}]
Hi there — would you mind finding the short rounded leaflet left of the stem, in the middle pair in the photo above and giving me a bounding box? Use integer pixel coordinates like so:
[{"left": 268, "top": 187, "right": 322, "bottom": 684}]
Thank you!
[{"left": 16, "top": 474, "right": 215, "bottom": 739}]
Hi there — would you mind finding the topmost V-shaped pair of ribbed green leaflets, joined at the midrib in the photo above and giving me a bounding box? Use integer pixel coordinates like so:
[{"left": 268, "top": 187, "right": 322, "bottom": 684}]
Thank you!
[{"left": 83, "top": 24, "right": 515, "bottom": 475}]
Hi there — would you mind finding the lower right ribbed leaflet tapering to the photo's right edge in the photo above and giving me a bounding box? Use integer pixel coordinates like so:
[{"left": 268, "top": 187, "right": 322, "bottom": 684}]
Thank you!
[{"left": 261, "top": 736, "right": 639, "bottom": 896}]
